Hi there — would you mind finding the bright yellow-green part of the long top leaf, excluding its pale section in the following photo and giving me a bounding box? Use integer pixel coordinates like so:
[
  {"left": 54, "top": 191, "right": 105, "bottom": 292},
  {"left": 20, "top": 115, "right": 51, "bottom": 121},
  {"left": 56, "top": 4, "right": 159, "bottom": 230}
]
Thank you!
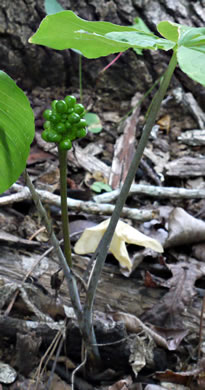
[{"left": 29, "top": 11, "right": 136, "bottom": 58}]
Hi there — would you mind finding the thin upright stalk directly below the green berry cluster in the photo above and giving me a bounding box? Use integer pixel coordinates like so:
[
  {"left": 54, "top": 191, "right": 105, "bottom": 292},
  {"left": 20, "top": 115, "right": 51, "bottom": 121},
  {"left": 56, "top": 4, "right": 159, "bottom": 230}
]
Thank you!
[{"left": 58, "top": 148, "right": 72, "bottom": 268}]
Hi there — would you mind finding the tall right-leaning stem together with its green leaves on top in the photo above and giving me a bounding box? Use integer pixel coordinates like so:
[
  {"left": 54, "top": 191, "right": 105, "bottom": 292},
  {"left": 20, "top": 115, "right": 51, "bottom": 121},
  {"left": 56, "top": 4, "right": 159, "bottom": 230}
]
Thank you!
[{"left": 30, "top": 11, "right": 205, "bottom": 368}]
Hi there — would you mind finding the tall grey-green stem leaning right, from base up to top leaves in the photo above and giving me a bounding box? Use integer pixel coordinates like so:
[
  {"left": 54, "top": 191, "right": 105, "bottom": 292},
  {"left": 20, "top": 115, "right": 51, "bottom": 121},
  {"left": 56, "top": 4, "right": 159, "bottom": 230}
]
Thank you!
[{"left": 84, "top": 52, "right": 177, "bottom": 333}]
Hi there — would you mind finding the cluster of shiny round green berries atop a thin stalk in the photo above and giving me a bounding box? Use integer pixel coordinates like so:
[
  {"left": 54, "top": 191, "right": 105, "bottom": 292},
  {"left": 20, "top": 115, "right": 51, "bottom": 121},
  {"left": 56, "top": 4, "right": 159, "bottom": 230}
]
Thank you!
[{"left": 41, "top": 95, "right": 87, "bottom": 150}]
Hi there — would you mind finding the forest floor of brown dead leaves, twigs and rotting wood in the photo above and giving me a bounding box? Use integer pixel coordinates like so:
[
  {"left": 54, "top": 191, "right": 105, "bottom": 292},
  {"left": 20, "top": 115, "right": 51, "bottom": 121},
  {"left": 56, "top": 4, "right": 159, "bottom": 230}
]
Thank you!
[{"left": 0, "top": 83, "right": 205, "bottom": 390}]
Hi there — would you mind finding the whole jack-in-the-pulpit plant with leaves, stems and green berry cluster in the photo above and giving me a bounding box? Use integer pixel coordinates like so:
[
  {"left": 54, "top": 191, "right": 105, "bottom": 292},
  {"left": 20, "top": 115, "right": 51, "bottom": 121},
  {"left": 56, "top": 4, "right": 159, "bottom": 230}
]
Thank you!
[{"left": 0, "top": 11, "right": 205, "bottom": 374}]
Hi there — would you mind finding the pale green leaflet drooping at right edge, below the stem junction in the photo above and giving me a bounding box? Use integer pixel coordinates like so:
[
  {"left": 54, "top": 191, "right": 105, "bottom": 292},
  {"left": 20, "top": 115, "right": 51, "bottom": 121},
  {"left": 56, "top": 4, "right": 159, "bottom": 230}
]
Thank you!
[{"left": 177, "top": 46, "right": 205, "bottom": 86}]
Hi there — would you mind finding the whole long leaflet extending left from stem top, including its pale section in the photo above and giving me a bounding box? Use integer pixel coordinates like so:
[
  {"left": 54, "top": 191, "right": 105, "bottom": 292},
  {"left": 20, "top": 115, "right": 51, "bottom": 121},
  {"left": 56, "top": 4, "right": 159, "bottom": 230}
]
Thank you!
[{"left": 29, "top": 11, "right": 174, "bottom": 58}]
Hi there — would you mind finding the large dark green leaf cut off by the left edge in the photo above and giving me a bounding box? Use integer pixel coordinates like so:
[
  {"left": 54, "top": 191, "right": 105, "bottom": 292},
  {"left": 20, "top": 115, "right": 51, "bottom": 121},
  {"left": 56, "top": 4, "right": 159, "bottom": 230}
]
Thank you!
[{"left": 0, "top": 71, "right": 34, "bottom": 193}]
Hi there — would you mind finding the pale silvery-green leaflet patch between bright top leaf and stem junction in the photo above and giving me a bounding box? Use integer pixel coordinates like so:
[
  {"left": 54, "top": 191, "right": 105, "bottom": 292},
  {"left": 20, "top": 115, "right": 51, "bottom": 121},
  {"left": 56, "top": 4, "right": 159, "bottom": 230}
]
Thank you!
[{"left": 106, "top": 31, "right": 175, "bottom": 50}]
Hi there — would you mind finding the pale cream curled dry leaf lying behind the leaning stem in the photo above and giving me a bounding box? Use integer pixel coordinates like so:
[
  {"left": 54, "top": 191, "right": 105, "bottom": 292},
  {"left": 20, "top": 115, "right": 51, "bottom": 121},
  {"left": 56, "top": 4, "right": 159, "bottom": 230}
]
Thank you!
[{"left": 74, "top": 219, "right": 163, "bottom": 270}]
